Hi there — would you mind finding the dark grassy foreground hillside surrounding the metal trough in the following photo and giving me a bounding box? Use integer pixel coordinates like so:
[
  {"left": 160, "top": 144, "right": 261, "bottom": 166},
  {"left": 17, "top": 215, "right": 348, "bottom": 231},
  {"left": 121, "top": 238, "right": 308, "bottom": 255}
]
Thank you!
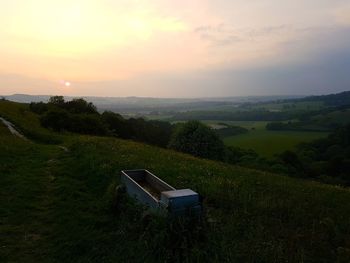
[{"left": 0, "top": 102, "right": 350, "bottom": 262}]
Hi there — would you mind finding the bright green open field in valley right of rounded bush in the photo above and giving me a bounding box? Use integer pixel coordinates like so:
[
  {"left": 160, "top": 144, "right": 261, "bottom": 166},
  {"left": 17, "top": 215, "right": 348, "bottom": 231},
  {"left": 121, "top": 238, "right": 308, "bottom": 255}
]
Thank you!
[{"left": 224, "top": 129, "right": 328, "bottom": 157}]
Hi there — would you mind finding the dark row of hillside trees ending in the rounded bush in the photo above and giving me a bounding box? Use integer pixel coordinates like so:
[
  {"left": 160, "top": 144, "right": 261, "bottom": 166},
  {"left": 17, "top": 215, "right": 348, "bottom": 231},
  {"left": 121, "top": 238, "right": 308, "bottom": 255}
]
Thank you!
[{"left": 30, "top": 96, "right": 232, "bottom": 161}]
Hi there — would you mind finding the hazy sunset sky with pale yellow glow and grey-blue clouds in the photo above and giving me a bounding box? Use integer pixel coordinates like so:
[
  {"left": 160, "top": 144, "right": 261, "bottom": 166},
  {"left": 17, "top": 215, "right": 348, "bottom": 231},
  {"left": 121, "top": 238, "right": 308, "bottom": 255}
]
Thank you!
[{"left": 0, "top": 0, "right": 350, "bottom": 97}]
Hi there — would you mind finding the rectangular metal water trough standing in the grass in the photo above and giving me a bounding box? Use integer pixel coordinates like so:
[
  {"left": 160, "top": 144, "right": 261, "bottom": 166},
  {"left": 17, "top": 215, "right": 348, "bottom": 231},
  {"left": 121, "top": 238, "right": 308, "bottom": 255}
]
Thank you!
[{"left": 121, "top": 169, "right": 202, "bottom": 215}]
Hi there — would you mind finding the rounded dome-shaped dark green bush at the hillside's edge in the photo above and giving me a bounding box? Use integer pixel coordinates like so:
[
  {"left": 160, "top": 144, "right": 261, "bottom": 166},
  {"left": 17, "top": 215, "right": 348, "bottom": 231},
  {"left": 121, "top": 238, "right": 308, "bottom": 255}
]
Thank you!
[{"left": 169, "top": 121, "right": 224, "bottom": 160}]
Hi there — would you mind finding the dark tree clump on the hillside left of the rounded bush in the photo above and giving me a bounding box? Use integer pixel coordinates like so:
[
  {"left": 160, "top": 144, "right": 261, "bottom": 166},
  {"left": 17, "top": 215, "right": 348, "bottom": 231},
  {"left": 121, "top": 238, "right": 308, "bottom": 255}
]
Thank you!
[{"left": 30, "top": 96, "right": 173, "bottom": 147}]
